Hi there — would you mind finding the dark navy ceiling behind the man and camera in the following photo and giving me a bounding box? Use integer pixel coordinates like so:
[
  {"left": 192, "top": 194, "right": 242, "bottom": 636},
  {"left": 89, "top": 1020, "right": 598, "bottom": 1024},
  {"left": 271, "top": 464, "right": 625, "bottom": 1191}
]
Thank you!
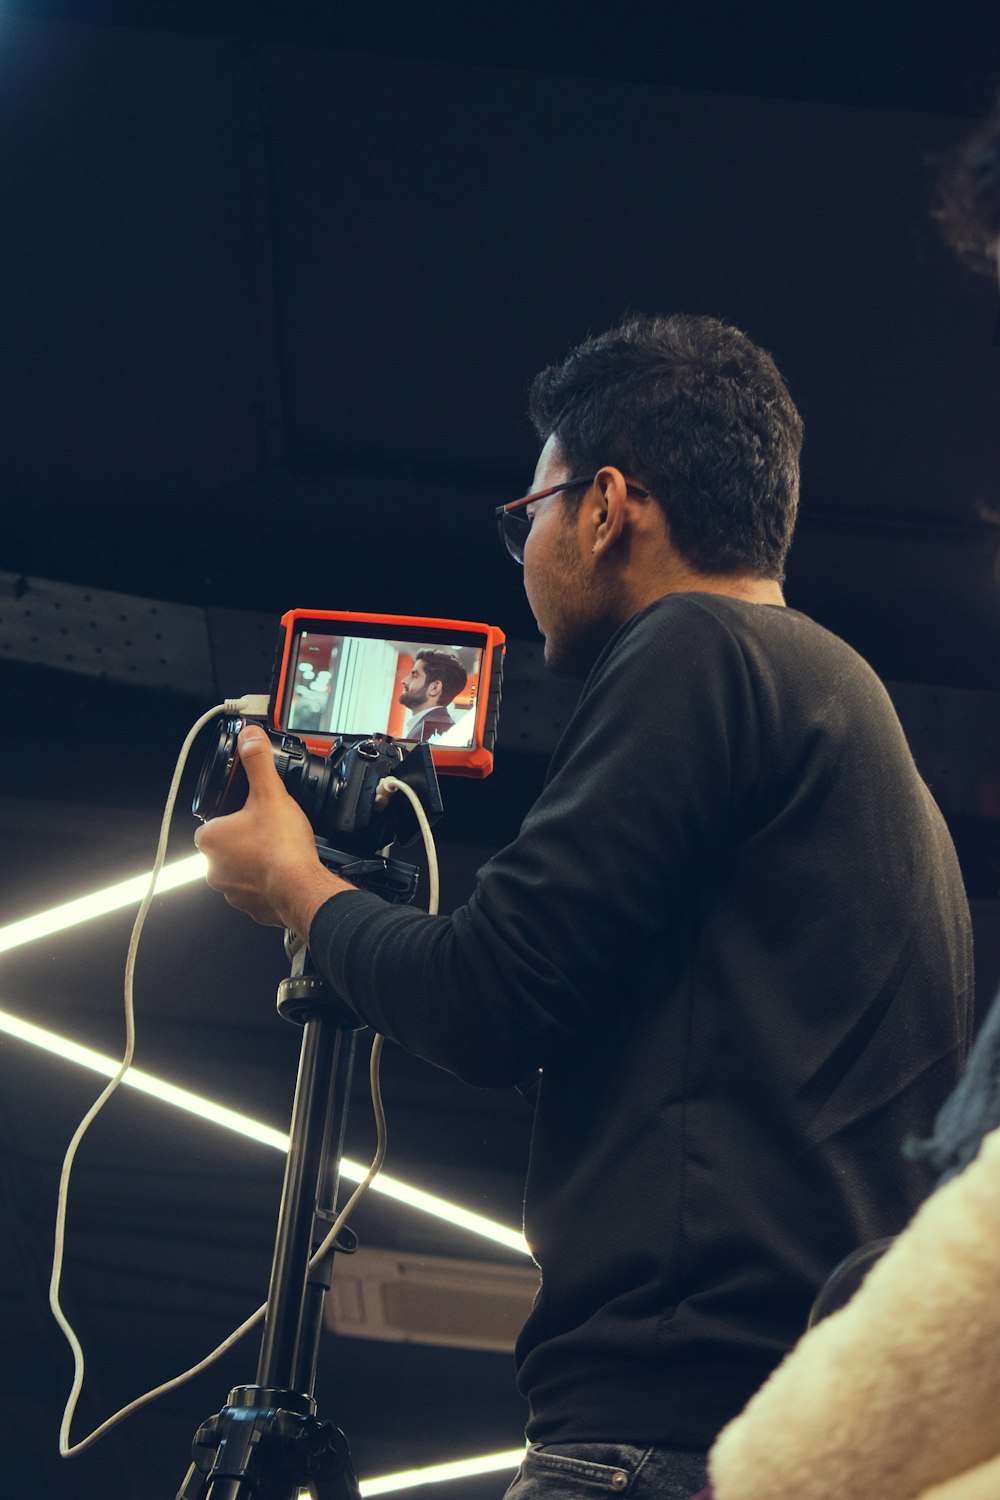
[{"left": 0, "top": 0, "right": 1000, "bottom": 1500}]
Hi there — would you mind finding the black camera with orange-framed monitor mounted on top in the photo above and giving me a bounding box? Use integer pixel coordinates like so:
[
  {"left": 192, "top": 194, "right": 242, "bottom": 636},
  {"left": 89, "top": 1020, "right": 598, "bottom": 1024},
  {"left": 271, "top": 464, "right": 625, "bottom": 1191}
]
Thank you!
[{"left": 192, "top": 609, "right": 505, "bottom": 870}]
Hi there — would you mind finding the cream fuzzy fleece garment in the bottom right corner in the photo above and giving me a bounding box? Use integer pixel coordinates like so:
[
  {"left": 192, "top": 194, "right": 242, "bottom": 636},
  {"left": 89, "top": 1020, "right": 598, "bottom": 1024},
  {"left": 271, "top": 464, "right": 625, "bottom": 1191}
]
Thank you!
[{"left": 709, "top": 1130, "right": 1000, "bottom": 1500}]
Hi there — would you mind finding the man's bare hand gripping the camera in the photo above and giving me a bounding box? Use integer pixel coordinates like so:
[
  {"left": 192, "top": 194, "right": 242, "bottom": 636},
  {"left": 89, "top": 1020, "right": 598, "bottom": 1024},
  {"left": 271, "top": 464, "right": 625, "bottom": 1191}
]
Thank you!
[{"left": 195, "top": 726, "right": 352, "bottom": 938}]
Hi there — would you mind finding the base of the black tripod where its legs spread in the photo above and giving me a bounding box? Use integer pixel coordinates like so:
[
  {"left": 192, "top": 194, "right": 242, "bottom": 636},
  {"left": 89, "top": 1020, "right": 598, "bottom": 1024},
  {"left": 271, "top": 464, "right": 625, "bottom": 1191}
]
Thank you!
[{"left": 177, "top": 1386, "right": 360, "bottom": 1500}]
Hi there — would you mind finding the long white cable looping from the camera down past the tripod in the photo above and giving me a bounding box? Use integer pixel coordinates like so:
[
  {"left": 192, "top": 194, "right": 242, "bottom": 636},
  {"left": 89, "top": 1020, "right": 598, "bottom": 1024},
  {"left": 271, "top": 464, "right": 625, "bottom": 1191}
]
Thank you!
[{"left": 49, "top": 720, "right": 439, "bottom": 1458}]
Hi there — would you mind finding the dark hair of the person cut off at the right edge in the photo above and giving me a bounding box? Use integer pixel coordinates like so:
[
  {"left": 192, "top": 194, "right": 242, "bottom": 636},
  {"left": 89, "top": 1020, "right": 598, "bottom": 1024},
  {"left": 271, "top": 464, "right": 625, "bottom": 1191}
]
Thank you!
[{"left": 936, "top": 101, "right": 1000, "bottom": 276}]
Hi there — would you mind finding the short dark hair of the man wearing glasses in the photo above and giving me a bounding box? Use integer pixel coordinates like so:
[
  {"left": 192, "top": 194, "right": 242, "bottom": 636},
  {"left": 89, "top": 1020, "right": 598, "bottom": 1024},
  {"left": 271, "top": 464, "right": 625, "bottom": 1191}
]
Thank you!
[{"left": 528, "top": 315, "right": 802, "bottom": 582}]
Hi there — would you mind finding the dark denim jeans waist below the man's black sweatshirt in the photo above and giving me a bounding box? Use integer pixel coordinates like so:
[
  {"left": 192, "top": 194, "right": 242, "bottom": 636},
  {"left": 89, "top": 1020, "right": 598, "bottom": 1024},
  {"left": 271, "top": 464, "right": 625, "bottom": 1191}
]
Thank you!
[{"left": 505, "top": 1443, "right": 708, "bottom": 1500}]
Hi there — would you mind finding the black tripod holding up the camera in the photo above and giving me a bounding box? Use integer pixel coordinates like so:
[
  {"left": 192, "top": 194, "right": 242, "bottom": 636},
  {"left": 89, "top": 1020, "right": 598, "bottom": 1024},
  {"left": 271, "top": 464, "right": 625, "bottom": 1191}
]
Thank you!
[{"left": 177, "top": 876, "right": 407, "bottom": 1500}]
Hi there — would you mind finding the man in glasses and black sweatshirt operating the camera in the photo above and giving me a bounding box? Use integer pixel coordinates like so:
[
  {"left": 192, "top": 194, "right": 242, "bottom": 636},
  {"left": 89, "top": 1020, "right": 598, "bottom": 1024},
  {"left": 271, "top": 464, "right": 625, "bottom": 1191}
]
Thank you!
[{"left": 199, "top": 318, "right": 972, "bottom": 1500}]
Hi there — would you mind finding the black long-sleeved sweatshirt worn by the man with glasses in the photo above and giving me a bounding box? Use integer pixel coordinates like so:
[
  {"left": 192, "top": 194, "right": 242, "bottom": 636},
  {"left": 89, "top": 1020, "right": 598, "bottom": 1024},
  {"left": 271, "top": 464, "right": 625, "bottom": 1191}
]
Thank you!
[{"left": 310, "top": 594, "right": 972, "bottom": 1448}]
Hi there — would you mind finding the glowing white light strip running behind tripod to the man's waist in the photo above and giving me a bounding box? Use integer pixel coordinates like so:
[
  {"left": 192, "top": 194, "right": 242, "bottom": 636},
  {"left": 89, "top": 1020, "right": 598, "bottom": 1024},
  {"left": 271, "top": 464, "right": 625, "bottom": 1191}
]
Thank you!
[{"left": 0, "top": 1011, "right": 531, "bottom": 1256}]
